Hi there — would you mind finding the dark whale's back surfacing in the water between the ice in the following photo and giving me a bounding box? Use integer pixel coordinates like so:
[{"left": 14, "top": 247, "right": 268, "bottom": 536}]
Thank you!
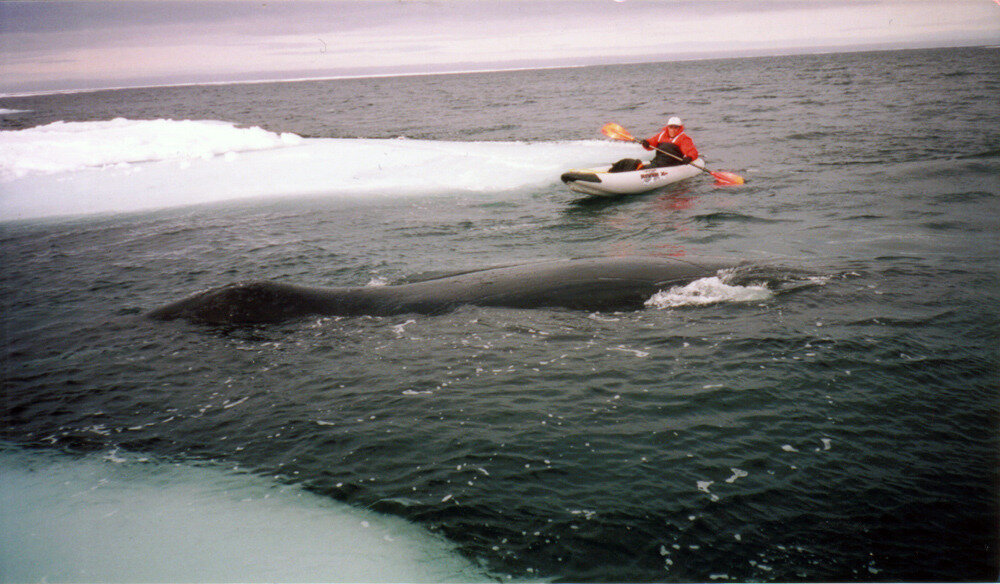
[{"left": 148, "top": 257, "right": 735, "bottom": 324}]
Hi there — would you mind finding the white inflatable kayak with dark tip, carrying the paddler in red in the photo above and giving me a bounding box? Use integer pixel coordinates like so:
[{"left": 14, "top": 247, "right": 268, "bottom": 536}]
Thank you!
[{"left": 560, "top": 158, "right": 705, "bottom": 197}]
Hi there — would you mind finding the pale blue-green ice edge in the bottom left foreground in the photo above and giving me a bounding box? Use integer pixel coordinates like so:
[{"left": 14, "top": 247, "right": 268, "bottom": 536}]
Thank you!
[{"left": 0, "top": 450, "right": 487, "bottom": 582}]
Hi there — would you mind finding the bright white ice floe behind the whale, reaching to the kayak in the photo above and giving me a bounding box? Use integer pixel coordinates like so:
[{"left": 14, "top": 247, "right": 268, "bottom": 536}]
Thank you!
[{"left": 0, "top": 119, "right": 639, "bottom": 220}]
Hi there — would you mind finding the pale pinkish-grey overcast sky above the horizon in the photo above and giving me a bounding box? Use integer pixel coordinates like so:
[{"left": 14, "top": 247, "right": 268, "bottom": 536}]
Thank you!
[{"left": 0, "top": 0, "right": 1000, "bottom": 95}]
